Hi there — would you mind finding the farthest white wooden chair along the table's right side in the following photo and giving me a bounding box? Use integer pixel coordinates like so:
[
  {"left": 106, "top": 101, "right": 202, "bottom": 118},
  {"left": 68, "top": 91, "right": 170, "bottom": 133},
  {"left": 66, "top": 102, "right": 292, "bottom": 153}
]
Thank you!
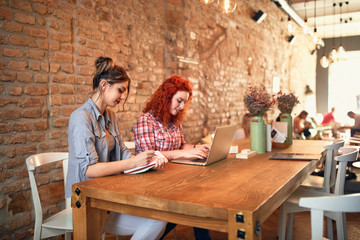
[{"left": 300, "top": 141, "right": 345, "bottom": 193}]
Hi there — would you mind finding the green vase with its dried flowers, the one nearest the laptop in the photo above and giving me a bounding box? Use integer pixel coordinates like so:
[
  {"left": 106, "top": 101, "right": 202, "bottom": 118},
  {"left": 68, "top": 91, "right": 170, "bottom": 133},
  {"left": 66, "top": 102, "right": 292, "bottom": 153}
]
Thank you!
[{"left": 244, "top": 86, "right": 275, "bottom": 153}]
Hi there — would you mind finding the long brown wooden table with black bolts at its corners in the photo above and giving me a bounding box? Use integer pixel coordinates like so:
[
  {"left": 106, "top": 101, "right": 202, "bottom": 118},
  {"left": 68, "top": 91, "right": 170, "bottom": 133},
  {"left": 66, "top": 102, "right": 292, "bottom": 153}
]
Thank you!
[{"left": 72, "top": 140, "right": 329, "bottom": 240}]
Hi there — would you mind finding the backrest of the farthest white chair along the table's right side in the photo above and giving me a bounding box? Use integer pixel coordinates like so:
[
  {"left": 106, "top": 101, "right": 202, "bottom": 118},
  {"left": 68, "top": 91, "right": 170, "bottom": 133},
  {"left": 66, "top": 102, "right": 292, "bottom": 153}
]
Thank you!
[{"left": 324, "top": 141, "right": 345, "bottom": 193}]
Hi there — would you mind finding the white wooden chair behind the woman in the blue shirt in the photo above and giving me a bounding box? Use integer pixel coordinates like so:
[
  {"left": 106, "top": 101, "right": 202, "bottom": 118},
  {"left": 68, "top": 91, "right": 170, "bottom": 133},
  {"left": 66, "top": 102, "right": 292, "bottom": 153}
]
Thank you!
[{"left": 26, "top": 152, "right": 73, "bottom": 240}]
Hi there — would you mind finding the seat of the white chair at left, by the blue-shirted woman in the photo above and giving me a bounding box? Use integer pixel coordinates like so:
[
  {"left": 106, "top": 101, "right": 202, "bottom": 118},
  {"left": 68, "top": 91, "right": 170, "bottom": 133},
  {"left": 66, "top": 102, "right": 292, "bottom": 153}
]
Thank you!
[{"left": 42, "top": 208, "right": 73, "bottom": 231}]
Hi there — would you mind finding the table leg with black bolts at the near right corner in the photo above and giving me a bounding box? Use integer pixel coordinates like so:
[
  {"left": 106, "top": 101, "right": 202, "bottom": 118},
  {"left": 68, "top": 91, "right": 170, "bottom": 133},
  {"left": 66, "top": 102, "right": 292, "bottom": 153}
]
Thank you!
[{"left": 228, "top": 210, "right": 261, "bottom": 240}]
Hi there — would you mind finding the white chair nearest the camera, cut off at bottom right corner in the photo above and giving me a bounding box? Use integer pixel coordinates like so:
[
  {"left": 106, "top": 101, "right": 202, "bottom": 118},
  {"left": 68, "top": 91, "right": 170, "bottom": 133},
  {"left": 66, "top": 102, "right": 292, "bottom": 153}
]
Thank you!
[{"left": 299, "top": 193, "right": 360, "bottom": 240}]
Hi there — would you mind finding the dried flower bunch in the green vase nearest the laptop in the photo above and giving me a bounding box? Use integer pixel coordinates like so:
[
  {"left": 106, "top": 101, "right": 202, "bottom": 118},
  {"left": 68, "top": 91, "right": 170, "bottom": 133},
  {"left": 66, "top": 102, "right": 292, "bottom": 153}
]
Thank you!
[{"left": 244, "top": 86, "right": 275, "bottom": 116}]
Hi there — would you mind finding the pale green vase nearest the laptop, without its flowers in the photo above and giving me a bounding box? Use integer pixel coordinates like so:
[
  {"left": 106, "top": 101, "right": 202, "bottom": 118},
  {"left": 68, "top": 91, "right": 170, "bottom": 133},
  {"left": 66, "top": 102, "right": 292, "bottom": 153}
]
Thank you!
[{"left": 250, "top": 116, "right": 265, "bottom": 153}]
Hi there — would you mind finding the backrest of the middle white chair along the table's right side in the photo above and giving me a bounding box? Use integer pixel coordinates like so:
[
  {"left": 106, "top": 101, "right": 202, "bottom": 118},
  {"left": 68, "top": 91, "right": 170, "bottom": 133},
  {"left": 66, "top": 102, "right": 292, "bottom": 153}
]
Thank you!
[{"left": 334, "top": 147, "right": 359, "bottom": 195}]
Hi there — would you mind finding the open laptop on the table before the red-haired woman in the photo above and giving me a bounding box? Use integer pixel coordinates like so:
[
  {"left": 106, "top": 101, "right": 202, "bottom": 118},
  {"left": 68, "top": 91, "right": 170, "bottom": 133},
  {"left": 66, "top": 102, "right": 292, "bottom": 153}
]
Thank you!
[{"left": 171, "top": 125, "right": 237, "bottom": 166}]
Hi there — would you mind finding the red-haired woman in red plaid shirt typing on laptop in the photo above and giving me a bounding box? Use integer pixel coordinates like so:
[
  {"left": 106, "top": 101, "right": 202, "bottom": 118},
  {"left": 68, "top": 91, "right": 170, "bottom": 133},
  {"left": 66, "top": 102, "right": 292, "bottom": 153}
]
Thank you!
[{"left": 134, "top": 75, "right": 210, "bottom": 239}]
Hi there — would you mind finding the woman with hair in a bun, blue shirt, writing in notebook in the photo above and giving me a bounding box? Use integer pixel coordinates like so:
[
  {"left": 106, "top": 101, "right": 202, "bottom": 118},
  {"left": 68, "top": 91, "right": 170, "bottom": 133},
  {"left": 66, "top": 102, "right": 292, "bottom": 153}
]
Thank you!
[{"left": 65, "top": 57, "right": 167, "bottom": 240}]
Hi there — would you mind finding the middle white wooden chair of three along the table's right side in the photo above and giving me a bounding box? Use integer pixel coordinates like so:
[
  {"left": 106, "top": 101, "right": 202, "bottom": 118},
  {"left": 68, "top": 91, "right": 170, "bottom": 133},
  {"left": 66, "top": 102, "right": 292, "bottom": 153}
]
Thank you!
[{"left": 278, "top": 147, "right": 359, "bottom": 240}]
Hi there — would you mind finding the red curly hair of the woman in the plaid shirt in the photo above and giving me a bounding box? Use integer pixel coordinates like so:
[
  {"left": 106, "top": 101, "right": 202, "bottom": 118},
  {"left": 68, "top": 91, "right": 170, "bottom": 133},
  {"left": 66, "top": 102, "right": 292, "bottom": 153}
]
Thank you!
[{"left": 143, "top": 74, "right": 192, "bottom": 126}]
